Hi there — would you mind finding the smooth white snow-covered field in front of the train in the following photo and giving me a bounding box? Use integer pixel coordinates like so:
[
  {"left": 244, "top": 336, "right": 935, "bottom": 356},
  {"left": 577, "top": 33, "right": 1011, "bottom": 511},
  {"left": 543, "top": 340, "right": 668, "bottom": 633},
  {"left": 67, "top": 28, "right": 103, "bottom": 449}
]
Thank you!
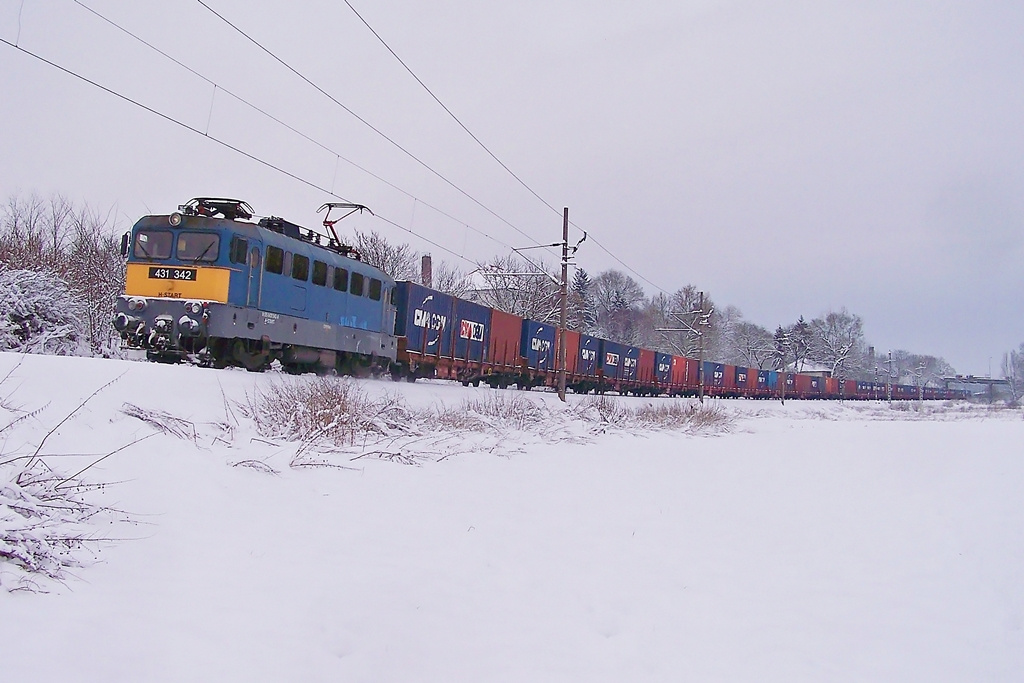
[{"left": 0, "top": 353, "right": 1024, "bottom": 682}]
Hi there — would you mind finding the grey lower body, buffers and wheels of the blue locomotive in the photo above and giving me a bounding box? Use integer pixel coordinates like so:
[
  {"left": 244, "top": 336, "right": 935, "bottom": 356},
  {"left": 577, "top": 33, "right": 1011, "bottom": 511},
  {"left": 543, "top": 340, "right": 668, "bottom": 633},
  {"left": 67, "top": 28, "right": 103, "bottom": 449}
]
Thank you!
[{"left": 114, "top": 297, "right": 390, "bottom": 377}]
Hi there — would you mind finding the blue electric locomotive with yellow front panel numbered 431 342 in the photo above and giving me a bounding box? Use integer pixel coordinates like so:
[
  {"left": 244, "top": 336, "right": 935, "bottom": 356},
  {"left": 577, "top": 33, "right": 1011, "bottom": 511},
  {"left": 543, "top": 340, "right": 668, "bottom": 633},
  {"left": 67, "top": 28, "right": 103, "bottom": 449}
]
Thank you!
[{"left": 115, "top": 198, "right": 396, "bottom": 374}]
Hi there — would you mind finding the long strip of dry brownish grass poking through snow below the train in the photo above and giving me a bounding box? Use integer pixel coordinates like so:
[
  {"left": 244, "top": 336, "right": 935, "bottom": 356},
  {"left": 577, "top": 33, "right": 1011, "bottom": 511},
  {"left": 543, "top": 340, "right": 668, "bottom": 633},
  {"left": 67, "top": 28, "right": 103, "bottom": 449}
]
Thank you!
[{"left": 239, "top": 377, "right": 732, "bottom": 467}]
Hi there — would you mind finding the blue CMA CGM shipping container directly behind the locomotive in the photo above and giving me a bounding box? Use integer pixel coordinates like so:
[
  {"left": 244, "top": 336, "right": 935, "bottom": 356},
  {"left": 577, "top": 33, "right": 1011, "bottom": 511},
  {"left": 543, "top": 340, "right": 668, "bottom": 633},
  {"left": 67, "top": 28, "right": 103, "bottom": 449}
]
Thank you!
[{"left": 394, "top": 282, "right": 454, "bottom": 356}]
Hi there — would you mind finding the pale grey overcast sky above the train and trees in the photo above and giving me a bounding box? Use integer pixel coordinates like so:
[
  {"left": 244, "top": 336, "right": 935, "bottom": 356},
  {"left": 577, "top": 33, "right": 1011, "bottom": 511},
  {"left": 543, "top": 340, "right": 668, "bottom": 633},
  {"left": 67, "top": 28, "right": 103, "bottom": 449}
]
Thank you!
[{"left": 0, "top": 0, "right": 1024, "bottom": 374}]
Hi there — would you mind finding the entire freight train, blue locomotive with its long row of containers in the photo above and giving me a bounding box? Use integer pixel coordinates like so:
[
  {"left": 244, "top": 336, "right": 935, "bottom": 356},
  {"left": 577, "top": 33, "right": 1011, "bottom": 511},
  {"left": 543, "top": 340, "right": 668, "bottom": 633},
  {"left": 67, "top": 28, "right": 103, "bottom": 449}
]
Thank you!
[{"left": 114, "top": 198, "right": 966, "bottom": 400}]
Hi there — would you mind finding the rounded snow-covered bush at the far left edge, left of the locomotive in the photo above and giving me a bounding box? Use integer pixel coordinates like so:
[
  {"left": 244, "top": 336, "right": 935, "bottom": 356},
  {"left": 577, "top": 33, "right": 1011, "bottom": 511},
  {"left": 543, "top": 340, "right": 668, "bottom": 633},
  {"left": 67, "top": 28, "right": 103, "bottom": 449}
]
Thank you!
[{"left": 0, "top": 270, "right": 88, "bottom": 355}]
